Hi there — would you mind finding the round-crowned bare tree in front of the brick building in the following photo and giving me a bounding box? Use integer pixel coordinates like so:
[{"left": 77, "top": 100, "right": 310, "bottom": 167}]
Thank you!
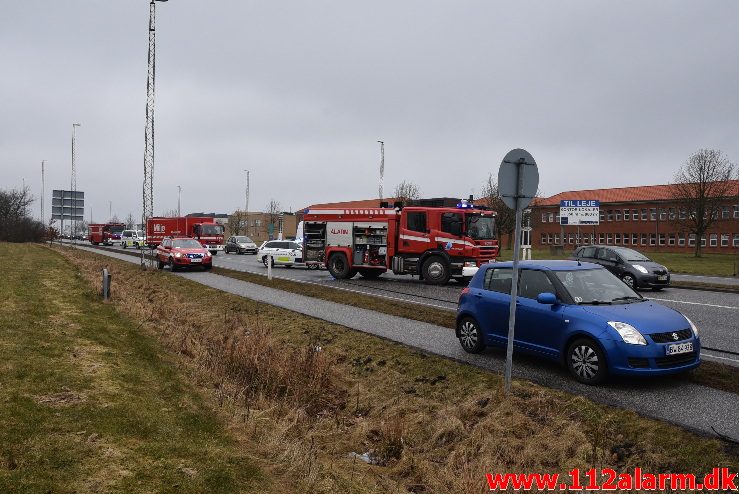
[{"left": 672, "top": 149, "right": 739, "bottom": 257}]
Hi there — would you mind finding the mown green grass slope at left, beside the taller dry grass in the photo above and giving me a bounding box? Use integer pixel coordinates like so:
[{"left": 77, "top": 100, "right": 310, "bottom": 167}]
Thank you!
[{"left": 0, "top": 243, "right": 266, "bottom": 493}]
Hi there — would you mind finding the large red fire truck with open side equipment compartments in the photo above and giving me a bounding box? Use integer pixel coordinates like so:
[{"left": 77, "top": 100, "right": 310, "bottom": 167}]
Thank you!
[{"left": 303, "top": 199, "right": 498, "bottom": 285}]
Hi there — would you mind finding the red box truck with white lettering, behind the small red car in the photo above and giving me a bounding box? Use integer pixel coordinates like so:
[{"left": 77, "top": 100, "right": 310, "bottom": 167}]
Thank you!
[{"left": 146, "top": 216, "right": 223, "bottom": 255}]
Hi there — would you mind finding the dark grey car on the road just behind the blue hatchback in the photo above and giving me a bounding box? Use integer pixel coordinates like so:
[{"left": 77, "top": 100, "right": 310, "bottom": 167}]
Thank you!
[{"left": 572, "top": 245, "right": 670, "bottom": 290}]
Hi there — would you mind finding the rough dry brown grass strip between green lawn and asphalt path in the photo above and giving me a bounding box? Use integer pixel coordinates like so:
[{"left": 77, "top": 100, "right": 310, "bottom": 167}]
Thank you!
[{"left": 53, "top": 245, "right": 739, "bottom": 493}]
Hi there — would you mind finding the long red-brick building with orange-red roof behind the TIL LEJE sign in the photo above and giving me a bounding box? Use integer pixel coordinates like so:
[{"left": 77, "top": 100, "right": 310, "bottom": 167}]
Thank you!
[{"left": 531, "top": 180, "right": 739, "bottom": 254}]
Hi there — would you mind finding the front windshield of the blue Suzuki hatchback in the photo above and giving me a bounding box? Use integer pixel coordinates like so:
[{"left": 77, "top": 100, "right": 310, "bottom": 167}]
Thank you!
[{"left": 554, "top": 269, "right": 644, "bottom": 305}]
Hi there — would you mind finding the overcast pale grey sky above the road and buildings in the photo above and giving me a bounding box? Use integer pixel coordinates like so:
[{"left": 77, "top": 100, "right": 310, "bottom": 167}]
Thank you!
[{"left": 0, "top": 0, "right": 739, "bottom": 221}]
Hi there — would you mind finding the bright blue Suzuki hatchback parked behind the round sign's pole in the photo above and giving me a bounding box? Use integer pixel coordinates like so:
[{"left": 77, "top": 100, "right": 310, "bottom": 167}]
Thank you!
[{"left": 457, "top": 261, "right": 701, "bottom": 384}]
